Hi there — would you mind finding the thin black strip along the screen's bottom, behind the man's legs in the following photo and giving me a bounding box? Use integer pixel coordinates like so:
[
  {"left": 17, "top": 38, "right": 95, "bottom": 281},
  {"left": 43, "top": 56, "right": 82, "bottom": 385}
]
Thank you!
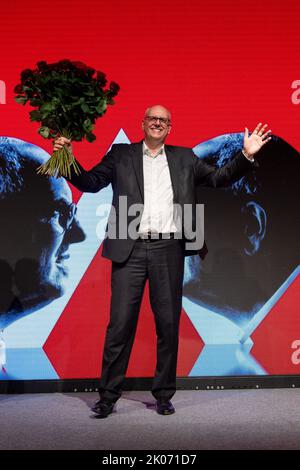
[{"left": 0, "top": 375, "right": 300, "bottom": 394}]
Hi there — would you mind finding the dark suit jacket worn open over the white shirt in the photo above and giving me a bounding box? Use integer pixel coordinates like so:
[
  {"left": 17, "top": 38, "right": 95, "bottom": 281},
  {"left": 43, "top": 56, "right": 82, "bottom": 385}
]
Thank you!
[{"left": 65, "top": 142, "right": 253, "bottom": 262}]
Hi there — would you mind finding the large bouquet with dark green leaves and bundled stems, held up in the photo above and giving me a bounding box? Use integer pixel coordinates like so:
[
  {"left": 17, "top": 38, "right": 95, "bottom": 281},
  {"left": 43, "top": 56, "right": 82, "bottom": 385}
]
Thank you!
[{"left": 14, "top": 59, "right": 120, "bottom": 178}]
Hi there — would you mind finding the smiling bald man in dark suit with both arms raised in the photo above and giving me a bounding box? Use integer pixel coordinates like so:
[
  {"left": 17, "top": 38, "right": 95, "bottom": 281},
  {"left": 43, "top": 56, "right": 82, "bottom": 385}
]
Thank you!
[{"left": 54, "top": 105, "right": 271, "bottom": 418}]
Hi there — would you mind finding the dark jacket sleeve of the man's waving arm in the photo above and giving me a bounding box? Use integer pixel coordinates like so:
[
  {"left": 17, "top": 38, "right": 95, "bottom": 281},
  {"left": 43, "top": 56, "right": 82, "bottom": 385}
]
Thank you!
[{"left": 194, "top": 152, "right": 258, "bottom": 188}]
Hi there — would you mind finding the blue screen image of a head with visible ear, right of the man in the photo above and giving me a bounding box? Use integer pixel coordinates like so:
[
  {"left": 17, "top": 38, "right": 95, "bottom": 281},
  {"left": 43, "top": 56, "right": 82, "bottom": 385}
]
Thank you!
[{"left": 183, "top": 133, "right": 300, "bottom": 375}]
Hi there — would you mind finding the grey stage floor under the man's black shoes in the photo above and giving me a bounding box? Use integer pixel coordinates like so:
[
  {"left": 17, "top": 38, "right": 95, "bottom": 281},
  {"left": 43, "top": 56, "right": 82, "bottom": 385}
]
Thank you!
[{"left": 0, "top": 389, "right": 300, "bottom": 450}]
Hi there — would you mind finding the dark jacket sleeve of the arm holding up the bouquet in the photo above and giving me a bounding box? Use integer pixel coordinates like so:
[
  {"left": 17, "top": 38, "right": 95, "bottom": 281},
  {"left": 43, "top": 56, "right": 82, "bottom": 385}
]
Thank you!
[{"left": 65, "top": 145, "right": 115, "bottom": 193}]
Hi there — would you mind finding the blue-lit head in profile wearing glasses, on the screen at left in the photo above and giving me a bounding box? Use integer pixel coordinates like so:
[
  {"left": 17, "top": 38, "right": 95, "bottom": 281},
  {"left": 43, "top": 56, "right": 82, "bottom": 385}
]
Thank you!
[{"left": 0, "top": 137, "right": 85, "bottom": 329}]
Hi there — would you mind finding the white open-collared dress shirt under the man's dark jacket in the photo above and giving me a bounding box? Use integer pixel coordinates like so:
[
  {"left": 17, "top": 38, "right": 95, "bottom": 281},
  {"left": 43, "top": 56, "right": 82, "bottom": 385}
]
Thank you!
[{"left": 139, "top": 142, "right": 177, "bottom": 234}]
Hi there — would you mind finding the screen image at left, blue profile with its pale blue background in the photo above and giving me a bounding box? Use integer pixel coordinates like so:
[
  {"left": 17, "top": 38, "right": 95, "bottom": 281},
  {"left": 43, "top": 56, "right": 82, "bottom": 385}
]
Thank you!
[{"left": 0, "top": 131, "right": 123, "bottom": 381}]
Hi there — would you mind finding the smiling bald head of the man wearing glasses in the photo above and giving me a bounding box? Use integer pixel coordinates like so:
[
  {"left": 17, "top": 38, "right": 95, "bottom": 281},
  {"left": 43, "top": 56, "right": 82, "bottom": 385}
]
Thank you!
[{"left": 142, "top": 105, "right": 171, "bottom": 146}]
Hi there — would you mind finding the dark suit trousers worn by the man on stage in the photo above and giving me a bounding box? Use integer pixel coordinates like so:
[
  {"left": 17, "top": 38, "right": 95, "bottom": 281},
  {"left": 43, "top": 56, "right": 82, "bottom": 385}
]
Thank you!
[{"left": 100, "top": 239, "right": 184, "bottom": 402}]
